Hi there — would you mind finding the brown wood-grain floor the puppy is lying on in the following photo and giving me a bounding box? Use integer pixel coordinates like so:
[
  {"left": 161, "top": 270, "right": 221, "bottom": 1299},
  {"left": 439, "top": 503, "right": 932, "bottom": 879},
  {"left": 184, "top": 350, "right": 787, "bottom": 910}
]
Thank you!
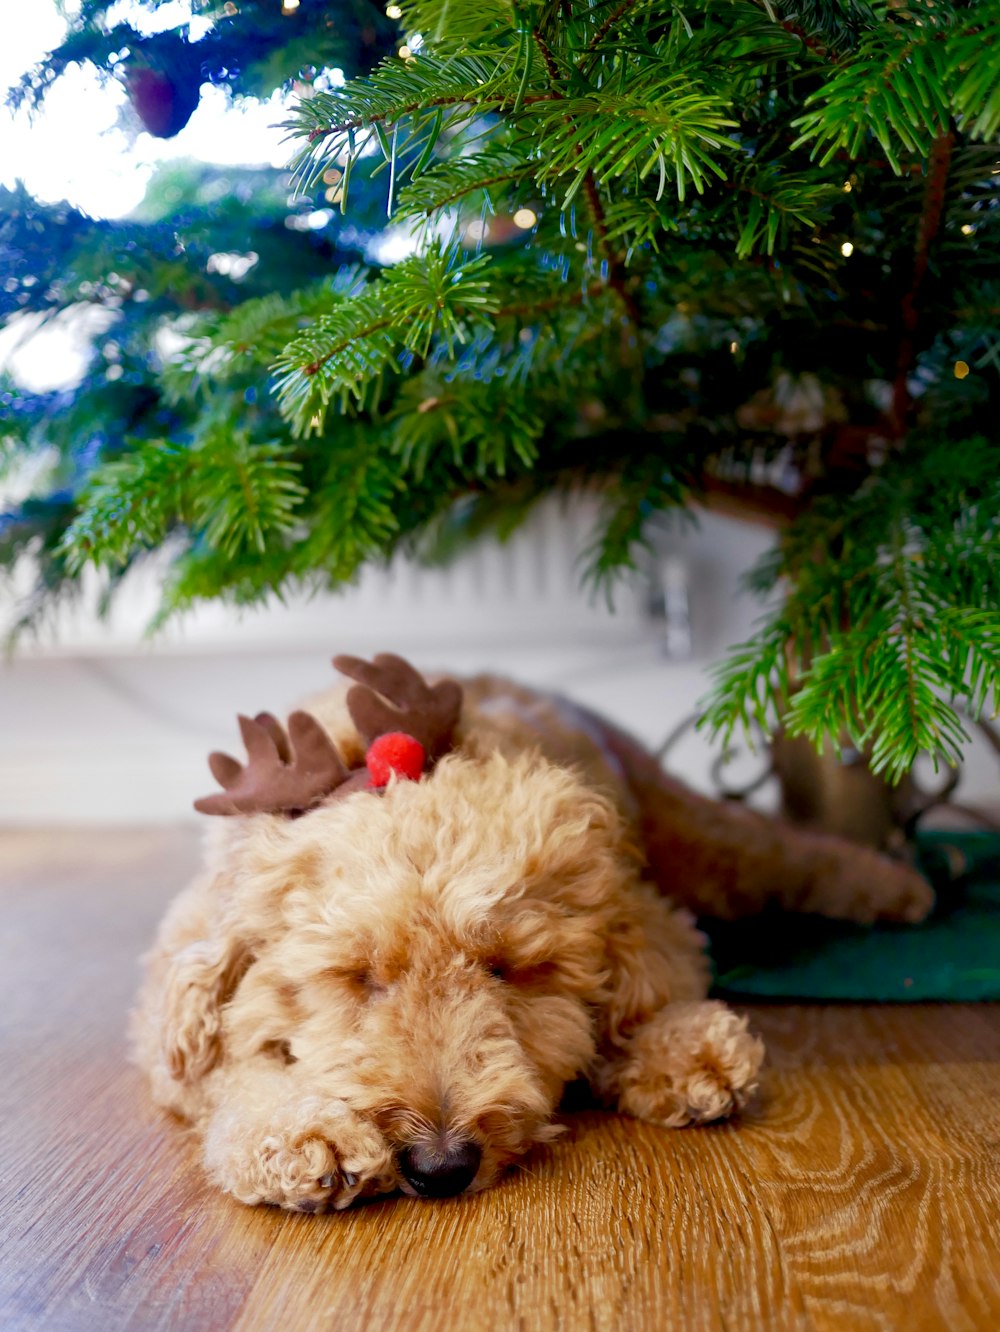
[{"left": 0, "top": 831, "right": 1000, "bottom": 1332}]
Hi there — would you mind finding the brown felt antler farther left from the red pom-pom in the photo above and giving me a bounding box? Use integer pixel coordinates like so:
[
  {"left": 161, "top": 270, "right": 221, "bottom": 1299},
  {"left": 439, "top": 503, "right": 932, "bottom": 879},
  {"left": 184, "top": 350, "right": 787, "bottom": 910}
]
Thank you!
[{"left": 194, "top": 713, "right": 368, "bottom": 814}]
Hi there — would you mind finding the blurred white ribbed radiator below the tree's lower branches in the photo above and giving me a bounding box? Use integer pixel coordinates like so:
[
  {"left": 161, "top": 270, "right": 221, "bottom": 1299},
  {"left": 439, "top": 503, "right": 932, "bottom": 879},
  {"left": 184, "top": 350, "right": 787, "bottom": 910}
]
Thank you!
[{"left": 0, "top": 503, "right": 647, "bottom": 657}]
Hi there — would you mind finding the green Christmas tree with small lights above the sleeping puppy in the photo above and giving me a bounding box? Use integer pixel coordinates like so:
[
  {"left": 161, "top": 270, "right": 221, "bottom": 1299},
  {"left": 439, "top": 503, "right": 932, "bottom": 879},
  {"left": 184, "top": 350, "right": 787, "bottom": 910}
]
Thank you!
[{"left": 0, "top": 0, "right": 1000, "bottom": 775}]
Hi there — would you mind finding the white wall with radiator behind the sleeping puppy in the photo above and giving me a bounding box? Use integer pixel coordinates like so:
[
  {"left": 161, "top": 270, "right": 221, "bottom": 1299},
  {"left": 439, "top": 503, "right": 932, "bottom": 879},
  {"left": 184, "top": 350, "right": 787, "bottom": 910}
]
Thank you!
[{"left": 0, "top": 507, "right": 1000, "bottom": 825}]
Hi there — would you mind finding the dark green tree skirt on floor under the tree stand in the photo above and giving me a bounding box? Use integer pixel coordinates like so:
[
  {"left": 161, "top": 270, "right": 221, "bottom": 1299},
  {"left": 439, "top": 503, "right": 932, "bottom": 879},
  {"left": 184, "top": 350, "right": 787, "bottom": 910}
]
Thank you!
[{"left": 702, "top": 833, "right": 1000, "bottom": 1003}]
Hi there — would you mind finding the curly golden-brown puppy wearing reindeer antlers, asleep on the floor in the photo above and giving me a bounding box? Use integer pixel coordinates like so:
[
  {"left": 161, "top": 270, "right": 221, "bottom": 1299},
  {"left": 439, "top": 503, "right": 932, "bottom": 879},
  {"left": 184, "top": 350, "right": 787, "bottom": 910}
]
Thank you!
[{"left": 133, "top": 657, "right": 931, "bottom": 1211}]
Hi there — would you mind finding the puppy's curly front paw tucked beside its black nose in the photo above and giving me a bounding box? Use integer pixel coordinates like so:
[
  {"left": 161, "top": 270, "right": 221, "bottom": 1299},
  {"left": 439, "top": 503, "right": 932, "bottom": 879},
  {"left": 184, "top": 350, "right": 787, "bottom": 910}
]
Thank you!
[{"left": 205, "top": 1103, "right": 395, "bottom": 1212}]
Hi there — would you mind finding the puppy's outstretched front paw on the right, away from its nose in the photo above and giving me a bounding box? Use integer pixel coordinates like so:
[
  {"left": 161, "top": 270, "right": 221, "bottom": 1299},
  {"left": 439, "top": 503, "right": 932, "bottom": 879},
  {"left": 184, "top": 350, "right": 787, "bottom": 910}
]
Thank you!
[{"left": 618, "top": 1002, "right": 764, "bottom": 1128}]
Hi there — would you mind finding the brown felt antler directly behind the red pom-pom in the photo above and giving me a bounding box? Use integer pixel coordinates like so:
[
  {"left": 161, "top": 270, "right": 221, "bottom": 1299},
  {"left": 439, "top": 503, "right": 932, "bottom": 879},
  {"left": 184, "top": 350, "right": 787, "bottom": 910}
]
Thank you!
[{"left": 333, "top": 653, "right": 462, "bottom": 763}]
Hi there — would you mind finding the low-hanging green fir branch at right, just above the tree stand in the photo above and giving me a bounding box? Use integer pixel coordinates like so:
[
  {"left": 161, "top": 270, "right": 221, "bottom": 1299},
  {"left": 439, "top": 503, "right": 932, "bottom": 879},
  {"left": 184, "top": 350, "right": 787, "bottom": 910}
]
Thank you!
[{"left": 706, "top": 440, "right": 1000, "bottom": 781}]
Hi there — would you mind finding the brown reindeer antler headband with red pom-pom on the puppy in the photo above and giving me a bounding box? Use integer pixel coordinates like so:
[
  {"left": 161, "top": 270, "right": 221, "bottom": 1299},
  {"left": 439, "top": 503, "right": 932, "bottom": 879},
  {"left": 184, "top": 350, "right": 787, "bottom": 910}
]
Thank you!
[{"left": 194, "top": 653, "right": 462, "bottom": 815}]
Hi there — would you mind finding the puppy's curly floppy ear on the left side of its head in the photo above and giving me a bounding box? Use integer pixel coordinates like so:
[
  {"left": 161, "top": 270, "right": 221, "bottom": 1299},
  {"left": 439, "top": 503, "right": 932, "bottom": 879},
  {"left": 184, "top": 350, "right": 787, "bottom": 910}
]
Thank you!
[{"left": 160, "top": 932, "right": 253, "bottom": 1084}]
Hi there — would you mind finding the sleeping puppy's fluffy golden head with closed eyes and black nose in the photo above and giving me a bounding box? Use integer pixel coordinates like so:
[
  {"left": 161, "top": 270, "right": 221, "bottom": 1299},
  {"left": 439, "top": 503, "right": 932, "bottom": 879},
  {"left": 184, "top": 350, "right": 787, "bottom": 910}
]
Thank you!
[{"left": 164, "top": 754, "right": 627, "bottom": 1196}]
